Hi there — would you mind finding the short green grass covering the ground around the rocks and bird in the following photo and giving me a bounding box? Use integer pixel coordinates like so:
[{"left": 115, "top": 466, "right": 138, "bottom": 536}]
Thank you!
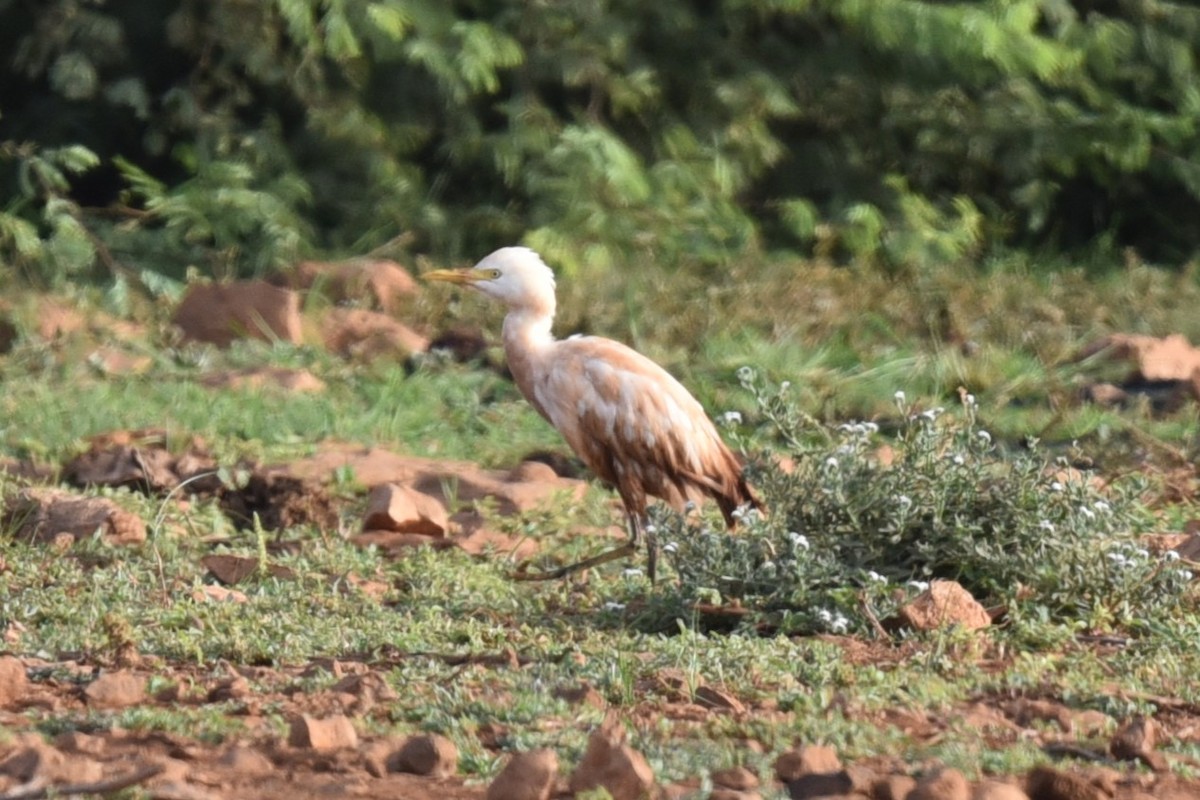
[{"left": 0, "top": 251, "right": 1200, "bottom": 796}]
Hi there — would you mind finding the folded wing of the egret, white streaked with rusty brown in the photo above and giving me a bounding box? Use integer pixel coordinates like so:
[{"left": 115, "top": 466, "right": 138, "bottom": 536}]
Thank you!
[{"left": 530, "top": 337, "right": 740, "bottom": 506}]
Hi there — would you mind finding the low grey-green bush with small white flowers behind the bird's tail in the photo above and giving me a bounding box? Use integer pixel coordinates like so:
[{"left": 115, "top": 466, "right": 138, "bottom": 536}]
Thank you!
[{"left": 660, "top": 369, "right": 1192, "bottom": 631}]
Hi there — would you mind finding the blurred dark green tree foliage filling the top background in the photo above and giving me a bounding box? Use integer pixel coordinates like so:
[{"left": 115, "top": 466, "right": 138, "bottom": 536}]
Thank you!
[{"left": 0, "top": 0, "right": 1200, "bottom": 287}]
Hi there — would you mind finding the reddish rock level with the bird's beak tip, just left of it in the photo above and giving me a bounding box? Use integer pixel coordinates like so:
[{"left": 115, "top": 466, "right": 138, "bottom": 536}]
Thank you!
[{"left": 279, "top": 258, "right": 418, "bottom": 313}]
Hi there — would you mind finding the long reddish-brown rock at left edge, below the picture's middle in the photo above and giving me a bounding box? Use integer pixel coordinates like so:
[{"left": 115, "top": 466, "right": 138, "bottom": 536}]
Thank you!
[{"left": 0, "top": 488, "right": 146, "bottom": 545}]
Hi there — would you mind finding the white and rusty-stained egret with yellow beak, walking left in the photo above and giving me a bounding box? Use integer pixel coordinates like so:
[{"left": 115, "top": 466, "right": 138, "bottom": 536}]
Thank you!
[{"left": 422, "top": 247, "right": 764, "bottom": 583}]
